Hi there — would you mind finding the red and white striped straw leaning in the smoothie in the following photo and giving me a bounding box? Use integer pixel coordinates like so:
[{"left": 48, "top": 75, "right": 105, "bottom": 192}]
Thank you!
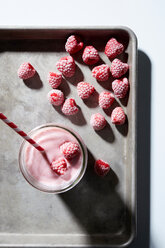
[{"left": 0, "top": 113, "right": 45, "bottom": 153}]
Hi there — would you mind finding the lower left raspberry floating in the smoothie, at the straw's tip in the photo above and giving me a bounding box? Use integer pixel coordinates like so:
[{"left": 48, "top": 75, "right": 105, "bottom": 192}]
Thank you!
[{"left": 50, "top": 158, "right": 67, "bottom": 176}]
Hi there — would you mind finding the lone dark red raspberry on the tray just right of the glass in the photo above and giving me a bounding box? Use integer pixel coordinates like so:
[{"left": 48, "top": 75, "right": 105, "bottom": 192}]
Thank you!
[{"left": 94, "top": 159, "right": 110, "bottom": 176}]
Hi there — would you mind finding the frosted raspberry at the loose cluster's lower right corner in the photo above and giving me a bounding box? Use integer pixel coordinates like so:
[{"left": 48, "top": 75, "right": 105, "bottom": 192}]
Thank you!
[{"left": 111, "top": 107, "right": 126, "bottom": 125}]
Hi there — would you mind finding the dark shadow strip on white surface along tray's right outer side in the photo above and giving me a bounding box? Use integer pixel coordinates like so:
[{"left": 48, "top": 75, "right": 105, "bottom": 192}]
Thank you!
[{"left": 128, "top": 51, "right": 152, "bottom": 248}]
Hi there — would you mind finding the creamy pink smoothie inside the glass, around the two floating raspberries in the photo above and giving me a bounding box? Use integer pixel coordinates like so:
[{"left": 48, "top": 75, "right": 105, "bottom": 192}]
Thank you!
[{"left": 24, "top": 127, "right": 83, "bottom": 190}]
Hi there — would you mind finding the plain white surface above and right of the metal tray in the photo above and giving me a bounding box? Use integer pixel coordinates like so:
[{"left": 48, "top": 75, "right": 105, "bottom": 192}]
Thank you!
[{"left": 0, "top": 0, "right": 165, "bottom": 248}]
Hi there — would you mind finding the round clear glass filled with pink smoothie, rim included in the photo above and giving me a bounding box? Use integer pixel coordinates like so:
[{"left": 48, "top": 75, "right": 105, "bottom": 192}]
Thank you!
[{"left": 19, "top": 124, "right": 87, "bottom": 193}]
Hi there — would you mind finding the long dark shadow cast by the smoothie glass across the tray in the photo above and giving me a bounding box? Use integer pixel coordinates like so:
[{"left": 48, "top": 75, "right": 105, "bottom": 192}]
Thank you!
[{"left": 60, "top": 148, "right": 131, "bottom": 245}]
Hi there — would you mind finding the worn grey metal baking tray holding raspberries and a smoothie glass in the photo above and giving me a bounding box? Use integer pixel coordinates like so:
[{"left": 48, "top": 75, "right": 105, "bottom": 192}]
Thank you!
[{"left": 0, "top": 27, "right": 137, "bottom": 247}]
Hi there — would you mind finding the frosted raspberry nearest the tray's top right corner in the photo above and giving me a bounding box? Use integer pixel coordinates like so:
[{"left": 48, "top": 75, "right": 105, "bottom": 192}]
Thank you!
[{"left": 105, "top": 38, "right": 124, "bottom": 59}]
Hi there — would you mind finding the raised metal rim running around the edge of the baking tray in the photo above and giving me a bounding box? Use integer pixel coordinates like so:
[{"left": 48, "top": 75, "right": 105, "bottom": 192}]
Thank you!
[{"left": 0, "top": 25, "right": 138, "bottom": 248}]
